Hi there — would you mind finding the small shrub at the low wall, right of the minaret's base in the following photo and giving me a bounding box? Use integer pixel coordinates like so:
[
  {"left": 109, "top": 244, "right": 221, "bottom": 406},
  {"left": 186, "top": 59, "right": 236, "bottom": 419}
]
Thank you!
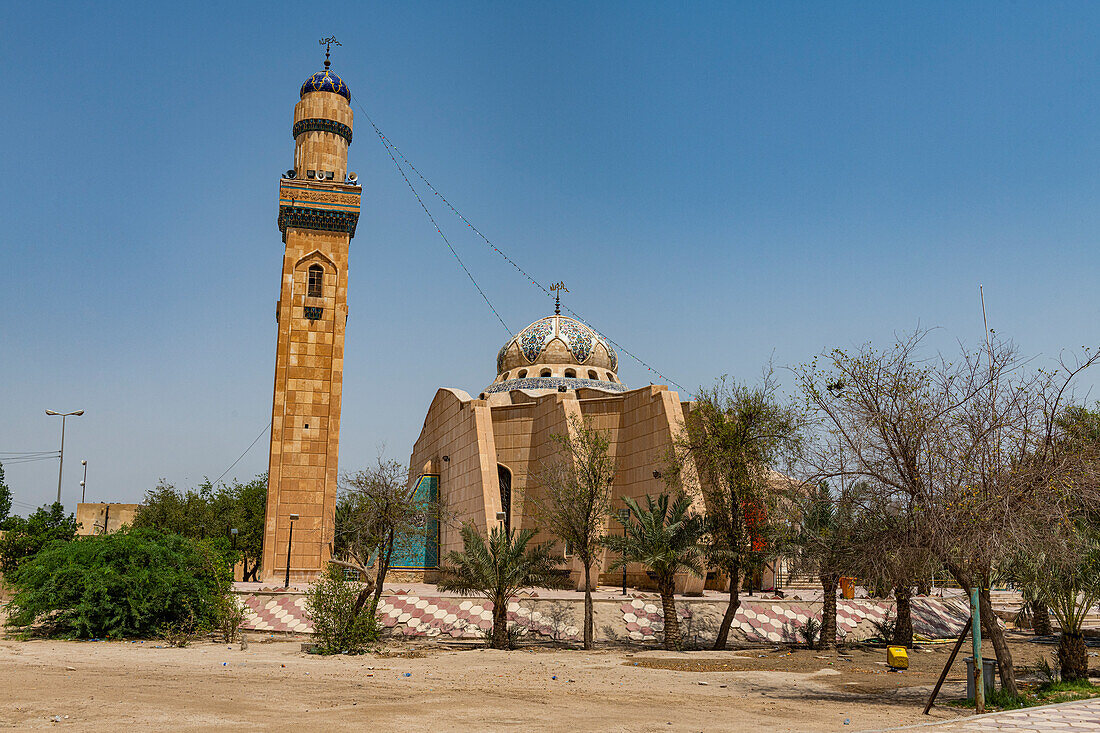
[{"left": 306, "top": 565, "right": 380, "bottom": 654}]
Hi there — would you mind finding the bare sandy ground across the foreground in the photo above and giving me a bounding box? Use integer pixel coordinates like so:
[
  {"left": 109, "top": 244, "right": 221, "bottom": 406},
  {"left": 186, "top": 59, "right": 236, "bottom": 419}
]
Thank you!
[{"left": 0, "top": 636, "right": 1048, "bottom": 733}]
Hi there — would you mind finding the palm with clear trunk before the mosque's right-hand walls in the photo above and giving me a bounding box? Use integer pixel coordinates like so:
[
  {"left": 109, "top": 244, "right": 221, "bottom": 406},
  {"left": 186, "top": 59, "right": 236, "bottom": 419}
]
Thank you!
[{"left": 604, "top": 494, "right": 705, "bottom": 649}]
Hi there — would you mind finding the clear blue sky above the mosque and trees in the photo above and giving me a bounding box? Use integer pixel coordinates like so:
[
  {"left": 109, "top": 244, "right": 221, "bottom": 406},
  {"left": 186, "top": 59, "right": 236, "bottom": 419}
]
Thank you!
[{"left": 0, "top": 2, "right": 1100, "bottom": 512}]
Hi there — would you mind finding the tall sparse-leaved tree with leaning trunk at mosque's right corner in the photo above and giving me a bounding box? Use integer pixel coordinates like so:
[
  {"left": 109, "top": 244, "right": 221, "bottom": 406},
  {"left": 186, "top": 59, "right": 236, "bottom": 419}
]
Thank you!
[{"left": 668, "top": 368, "right": 803, "bottom": 649}]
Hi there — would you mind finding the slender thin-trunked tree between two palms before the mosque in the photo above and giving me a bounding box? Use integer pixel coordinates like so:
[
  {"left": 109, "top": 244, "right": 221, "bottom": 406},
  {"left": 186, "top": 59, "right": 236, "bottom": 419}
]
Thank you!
[{"left": 535, "top": 417, "right": 615, "bottom": 649}]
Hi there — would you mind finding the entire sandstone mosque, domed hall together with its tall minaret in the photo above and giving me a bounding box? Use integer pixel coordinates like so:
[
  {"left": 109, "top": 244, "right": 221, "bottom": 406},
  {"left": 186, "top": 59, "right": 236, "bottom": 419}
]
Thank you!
[{"left": 262, "top": 57, "right": 726, "bottom": 590}]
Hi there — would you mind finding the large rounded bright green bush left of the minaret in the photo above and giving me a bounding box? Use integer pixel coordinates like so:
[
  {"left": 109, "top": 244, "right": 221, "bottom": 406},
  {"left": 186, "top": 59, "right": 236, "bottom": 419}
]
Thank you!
[{"left": 8, "top": 529, "right": 230, "bottom": 638}]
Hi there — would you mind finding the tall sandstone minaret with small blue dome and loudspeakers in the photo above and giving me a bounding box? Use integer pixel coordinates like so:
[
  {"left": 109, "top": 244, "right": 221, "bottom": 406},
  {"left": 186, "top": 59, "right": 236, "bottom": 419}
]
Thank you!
[{"left": 262, "top": 45, "right": 360, "bottom": 586}]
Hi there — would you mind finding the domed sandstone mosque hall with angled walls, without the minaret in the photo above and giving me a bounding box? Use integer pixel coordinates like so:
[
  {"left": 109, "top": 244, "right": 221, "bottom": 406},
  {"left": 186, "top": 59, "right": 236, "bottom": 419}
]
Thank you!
[{"left": 394, "top": 313, "right": 704, "bottom": 591}]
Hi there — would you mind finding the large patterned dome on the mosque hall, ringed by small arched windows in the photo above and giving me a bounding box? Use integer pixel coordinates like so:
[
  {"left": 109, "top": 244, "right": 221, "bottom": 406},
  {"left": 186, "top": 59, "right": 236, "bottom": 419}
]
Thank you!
[{"left": 485, "top": 315, "right": 626, "bottom": 392}]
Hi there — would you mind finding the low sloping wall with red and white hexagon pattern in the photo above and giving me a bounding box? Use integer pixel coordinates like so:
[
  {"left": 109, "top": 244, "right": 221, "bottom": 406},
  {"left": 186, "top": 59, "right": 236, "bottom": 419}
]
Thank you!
[{"left": 242, "top": 593, "right": 966, "bottom": 645}]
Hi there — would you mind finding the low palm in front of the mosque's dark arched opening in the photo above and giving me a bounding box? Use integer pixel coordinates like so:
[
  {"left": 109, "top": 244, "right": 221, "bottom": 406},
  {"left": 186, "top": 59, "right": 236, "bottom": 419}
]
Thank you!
[{"left": 439, "top": 523, "right": 569, "bottom": 649}]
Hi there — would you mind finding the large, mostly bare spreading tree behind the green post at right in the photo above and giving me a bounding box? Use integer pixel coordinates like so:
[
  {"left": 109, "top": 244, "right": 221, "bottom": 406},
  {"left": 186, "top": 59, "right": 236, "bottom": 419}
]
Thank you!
[{"left": 795, "top": 331, "right": 1097, "bottom": 694}]
